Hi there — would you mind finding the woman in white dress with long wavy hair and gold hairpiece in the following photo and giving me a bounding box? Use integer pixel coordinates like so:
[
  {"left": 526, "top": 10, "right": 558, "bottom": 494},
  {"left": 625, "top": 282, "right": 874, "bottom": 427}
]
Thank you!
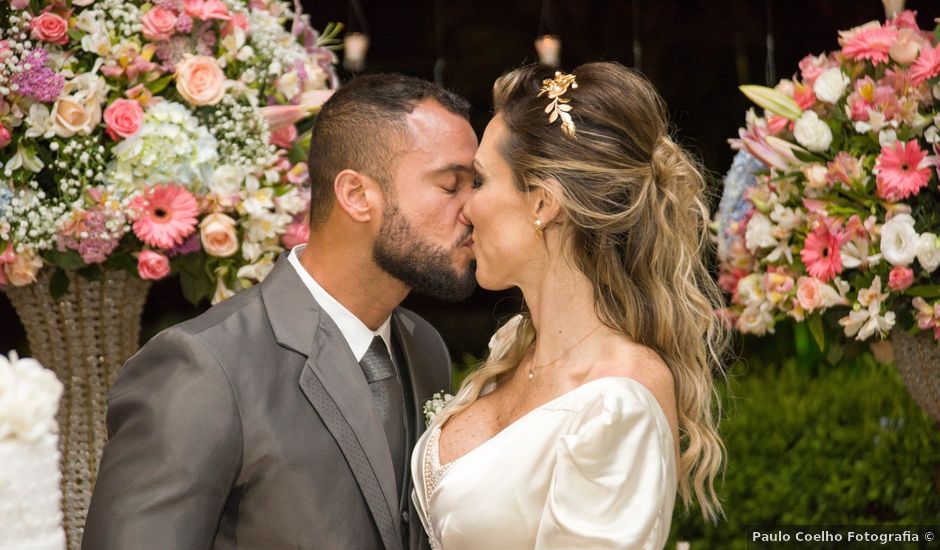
[{"left": 412, "top": 63, "right": 723, "bottom": 550}]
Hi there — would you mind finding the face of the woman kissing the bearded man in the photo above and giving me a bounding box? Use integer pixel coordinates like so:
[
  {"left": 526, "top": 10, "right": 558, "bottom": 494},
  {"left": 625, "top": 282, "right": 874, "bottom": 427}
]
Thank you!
[{"left": 464, "top": 114, "right": 543, "bottom": 290}]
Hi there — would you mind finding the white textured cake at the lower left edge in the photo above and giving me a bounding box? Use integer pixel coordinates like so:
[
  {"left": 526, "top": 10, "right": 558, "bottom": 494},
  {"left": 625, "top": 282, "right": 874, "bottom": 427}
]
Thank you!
[{"left": 0, "top": 353, "right": 65, "bottom": 550}]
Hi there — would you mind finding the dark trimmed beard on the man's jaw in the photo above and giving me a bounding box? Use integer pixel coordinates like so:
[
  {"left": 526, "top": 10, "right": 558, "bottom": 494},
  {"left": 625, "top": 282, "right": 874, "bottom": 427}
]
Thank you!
[{"left": 372, "top": 202, "right": 476, "bottom": 302}]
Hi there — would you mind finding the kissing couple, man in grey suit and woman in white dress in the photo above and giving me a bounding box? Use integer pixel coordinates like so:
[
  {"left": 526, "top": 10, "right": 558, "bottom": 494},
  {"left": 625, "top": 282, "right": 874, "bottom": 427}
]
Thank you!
[{"left": 83, "top": 63, "right": 724, "bottom": 550}]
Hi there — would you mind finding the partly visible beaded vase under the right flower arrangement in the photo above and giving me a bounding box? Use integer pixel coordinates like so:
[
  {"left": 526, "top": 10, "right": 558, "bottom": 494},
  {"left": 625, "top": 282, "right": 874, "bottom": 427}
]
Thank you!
[{"left": 891, "top": 330, "right": 940, "bottom": 422}]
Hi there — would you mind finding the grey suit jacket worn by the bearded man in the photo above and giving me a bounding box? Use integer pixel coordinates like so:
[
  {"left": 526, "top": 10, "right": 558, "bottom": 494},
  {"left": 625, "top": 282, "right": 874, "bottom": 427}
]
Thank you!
[{"left": 82, "top": 257, "right": 450, "bottom": 550}]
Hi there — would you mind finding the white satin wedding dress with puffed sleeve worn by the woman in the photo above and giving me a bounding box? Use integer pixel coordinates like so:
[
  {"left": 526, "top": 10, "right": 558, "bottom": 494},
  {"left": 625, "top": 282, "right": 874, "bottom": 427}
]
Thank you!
[{"left": 411, "top": 377, "right": 676, "bottom": 550}]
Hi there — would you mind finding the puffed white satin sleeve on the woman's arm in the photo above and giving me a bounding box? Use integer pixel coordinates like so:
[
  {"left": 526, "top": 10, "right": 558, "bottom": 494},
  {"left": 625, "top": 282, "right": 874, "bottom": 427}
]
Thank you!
[{"left": 535, "top": 381, "right": 676, "bottom": 549}]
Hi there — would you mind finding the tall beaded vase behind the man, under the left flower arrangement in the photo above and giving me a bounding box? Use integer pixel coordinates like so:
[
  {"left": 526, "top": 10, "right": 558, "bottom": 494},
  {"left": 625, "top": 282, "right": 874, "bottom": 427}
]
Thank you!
[{"left": 4, "top": 269, "right": 150, "bottom": 550}]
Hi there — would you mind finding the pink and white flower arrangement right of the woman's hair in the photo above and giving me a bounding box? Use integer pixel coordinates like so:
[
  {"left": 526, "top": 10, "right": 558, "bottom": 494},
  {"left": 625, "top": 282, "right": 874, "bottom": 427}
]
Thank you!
[{"left": 716, "top": 11, "right": 940, "bottom": 346}]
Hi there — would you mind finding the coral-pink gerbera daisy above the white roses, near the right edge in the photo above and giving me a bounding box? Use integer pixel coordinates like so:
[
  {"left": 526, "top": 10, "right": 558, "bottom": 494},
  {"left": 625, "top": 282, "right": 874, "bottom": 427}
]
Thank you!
[{"left": 875, "top": 140, "right": 931, "bottom": 201}]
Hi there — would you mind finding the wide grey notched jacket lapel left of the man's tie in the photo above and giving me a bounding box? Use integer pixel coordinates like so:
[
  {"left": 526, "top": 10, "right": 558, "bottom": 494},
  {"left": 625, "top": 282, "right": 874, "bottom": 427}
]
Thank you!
[{"left": 261, "top": 256, "right": 401, "bottom": 550}]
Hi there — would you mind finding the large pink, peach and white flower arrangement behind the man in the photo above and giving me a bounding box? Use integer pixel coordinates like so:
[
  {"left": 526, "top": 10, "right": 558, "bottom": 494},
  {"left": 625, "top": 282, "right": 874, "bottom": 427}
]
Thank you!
[{"left": 0, "top": 0, "right": 340, "bottom": 302}]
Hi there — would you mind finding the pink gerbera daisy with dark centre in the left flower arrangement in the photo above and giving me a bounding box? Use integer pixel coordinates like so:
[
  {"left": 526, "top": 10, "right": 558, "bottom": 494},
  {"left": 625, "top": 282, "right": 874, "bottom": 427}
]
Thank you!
[{"left": 131, "top": 184, "right": 199, "bottom": 248}]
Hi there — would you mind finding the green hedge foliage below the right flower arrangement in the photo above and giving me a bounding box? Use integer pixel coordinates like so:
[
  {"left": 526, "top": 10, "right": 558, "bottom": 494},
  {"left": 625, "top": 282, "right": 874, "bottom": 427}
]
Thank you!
[{"left": 669, "top": 354, "right": 940, "bottom": 548}]
